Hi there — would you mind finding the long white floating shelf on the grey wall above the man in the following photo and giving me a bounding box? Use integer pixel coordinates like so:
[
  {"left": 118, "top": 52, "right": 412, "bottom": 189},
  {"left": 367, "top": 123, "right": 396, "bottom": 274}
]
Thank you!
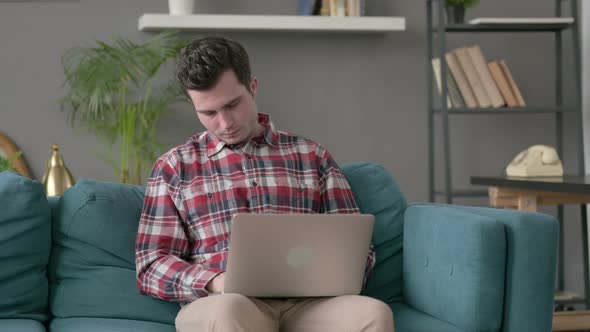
[{"left": 139, "top": 14, "right": 406, "bottom": 33}]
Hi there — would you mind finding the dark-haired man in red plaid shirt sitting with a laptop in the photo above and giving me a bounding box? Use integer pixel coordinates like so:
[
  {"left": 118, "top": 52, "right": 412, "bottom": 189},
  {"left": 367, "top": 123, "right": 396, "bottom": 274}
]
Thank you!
[{"left": 136, "top": 37, "right": 393, "bottom": 332}]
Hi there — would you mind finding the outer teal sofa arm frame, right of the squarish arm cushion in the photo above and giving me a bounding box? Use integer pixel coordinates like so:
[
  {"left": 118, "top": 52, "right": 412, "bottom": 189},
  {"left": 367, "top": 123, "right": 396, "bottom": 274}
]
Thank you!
[{"left": 448, "top": 206, "right": 559, "bottom": 332}]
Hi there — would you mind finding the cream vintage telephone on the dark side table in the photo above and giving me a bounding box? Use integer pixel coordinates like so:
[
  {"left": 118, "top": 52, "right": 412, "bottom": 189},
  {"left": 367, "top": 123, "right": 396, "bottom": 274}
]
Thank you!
[{"left": 506, "top": 145, "right": 563, "bottom": 176}]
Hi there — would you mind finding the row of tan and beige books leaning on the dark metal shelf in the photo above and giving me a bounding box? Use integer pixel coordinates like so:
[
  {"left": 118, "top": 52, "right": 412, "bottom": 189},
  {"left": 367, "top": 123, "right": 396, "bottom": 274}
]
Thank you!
[{"left": 432, "top": 45, "right": 526, "bottom": 108}]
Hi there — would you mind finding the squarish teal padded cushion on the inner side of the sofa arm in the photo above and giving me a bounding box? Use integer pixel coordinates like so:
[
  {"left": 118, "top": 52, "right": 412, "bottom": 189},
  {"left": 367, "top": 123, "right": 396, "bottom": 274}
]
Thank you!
[{"left": 403, "top": 204, "right": 506, "bottom": 331}]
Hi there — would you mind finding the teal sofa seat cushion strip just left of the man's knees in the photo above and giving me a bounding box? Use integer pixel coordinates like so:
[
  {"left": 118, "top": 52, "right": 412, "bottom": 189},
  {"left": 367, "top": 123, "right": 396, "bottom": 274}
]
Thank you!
[{"left": 49, "top": 318, "right": 175, "bottom": 332}]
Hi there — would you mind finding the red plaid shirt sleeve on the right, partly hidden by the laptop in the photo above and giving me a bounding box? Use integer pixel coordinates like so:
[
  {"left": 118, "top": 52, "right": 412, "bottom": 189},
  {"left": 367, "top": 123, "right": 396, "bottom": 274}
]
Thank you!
[{"left": 318, "top": 149, "right": 376, "bottom": 287}]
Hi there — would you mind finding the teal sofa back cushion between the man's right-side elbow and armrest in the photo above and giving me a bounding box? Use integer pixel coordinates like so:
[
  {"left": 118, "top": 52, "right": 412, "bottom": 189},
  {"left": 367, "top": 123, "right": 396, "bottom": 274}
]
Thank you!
[{"left": 341, "top": 163, "right": 407, "bottom": 302}]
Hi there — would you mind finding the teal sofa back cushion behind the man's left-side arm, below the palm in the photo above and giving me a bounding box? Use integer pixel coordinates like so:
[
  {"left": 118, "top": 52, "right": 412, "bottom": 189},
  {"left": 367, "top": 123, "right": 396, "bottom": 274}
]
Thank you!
[{"left": 49, "top": 179, "right": 180, "bottom": 324}]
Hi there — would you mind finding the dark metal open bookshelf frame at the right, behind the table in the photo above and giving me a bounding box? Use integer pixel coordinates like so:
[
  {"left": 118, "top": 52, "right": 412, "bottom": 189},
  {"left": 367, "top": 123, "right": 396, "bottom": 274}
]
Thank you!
[{"left": 426, "top": 0, "right": 590, "bottom": 331}]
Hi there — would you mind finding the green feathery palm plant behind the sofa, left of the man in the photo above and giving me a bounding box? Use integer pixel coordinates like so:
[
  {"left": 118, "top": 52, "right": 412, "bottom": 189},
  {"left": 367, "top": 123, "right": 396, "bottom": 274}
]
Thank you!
[{"left": 60, "top": 31, "right": 186, "bottom": 184}]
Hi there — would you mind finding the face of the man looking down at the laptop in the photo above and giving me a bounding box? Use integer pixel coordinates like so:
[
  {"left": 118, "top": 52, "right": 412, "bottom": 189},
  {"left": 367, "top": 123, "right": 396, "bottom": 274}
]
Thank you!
[{"left": 188, "top": 70, "right": 262, "bottom": 145}]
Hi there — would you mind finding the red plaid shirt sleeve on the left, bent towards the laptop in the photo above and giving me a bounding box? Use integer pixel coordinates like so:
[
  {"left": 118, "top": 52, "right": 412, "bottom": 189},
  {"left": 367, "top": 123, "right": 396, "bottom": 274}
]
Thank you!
[{"left": 135, "top": 159, "right": 223, "bottom": 303}]
